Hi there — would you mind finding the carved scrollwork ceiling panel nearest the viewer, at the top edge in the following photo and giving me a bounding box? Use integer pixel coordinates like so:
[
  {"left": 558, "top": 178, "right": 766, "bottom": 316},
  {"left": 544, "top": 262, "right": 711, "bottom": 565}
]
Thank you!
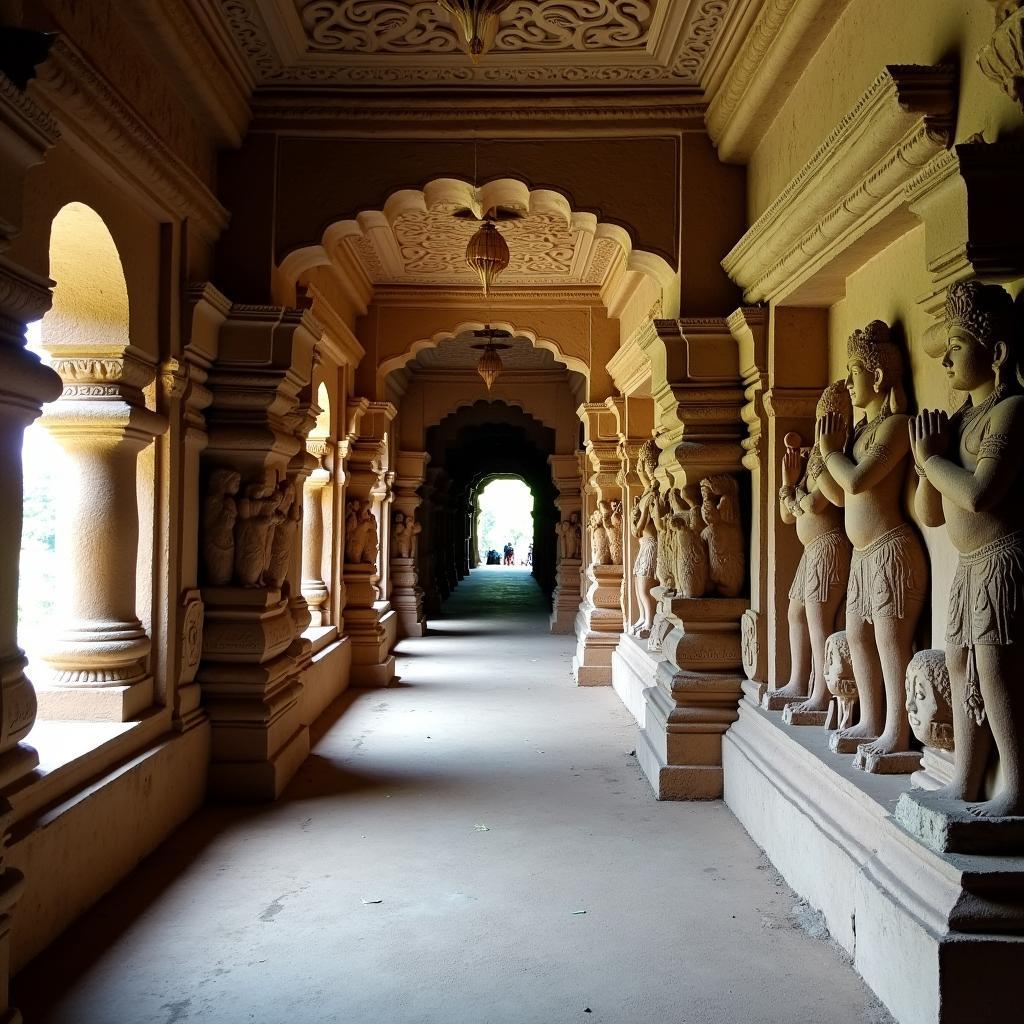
[{"left": 217, "top": 0, "right": 740, "bottom": 90}]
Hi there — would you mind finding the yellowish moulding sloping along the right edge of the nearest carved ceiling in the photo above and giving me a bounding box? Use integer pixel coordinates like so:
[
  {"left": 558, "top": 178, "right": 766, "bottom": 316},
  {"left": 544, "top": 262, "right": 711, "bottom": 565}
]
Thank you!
[{"left": 706, "top": 0, "right": 850, "bottom": 163}]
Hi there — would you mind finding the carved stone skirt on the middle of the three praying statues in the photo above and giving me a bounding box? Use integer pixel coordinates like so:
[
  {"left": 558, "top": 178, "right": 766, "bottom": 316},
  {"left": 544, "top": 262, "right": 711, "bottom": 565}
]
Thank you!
[{"left": 846, "top": 523, "right": 928, "bottom": 623}]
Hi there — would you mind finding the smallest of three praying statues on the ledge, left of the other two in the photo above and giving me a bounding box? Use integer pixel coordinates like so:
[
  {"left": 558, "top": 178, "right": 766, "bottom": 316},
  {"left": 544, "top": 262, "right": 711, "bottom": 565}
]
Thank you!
[{"left": 772, "top": 381, "right": 853, "bottom": 713}]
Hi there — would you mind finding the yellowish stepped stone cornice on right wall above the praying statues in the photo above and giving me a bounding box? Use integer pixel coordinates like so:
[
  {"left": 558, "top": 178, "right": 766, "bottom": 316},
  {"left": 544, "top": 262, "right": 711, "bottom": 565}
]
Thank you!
[{"left": 722, "top": 66, "right": 956, "bottom": 304}]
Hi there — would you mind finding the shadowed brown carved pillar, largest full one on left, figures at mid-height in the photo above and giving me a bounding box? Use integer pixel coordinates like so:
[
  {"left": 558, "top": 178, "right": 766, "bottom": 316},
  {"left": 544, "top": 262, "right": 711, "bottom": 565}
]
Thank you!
[{"left": 197, "top": 306, "right": 321, "bottom": 800}]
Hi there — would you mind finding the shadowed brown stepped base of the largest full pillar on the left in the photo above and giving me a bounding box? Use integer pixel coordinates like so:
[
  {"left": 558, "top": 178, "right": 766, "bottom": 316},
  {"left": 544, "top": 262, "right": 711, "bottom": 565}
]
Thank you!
[{"left": 197, "top": 587, "right": 309, "bottom": 800}]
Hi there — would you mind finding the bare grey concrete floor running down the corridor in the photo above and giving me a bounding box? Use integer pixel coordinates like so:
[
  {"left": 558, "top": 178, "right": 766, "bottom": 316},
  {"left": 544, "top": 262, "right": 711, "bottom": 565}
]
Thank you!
[{"left": 13, "top": 567, "right": 888, "bottom": 1024}]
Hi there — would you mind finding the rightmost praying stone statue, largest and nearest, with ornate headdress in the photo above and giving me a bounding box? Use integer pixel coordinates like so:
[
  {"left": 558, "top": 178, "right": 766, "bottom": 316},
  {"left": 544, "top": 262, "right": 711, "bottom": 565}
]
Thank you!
[{"left": 910, "top": 282, "right": 1024, "bottom": 817}]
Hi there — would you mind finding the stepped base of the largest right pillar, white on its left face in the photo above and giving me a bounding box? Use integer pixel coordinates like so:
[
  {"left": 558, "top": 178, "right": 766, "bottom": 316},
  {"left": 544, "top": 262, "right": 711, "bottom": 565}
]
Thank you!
[{"left": 637, "top": 598, "right": 748, "bottom": 800}]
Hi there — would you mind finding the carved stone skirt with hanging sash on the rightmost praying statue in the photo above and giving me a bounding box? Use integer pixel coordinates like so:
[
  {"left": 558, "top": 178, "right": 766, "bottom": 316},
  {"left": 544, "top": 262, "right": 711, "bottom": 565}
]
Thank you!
[{"left": 946, "top": 530, "right": 1024, "bottom": 725}]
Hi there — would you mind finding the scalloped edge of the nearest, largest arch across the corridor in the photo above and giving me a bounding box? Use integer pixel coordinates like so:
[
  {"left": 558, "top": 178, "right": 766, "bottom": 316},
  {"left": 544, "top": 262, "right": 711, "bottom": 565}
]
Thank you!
[{"left": 279, "top": 177, "right": 677, "bottom": 308}]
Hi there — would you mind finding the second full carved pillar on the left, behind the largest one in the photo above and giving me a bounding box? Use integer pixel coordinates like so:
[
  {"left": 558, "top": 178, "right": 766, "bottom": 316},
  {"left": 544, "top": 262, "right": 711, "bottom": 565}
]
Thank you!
[{"left": 344, "top": 398, "right": 398, "bottom": 686}]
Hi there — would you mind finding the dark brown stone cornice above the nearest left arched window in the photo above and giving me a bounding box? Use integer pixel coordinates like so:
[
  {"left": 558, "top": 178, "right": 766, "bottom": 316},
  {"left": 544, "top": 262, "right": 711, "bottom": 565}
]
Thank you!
[{"left": 30, "top": 36, "right": 227, "bottom": 242}]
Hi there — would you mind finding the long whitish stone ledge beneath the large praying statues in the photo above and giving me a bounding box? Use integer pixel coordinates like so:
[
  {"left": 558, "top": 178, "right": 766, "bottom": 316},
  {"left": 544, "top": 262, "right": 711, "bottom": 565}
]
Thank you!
[{"left": 723, "top": 700, "right": 1024, "bottom": 1024}]
